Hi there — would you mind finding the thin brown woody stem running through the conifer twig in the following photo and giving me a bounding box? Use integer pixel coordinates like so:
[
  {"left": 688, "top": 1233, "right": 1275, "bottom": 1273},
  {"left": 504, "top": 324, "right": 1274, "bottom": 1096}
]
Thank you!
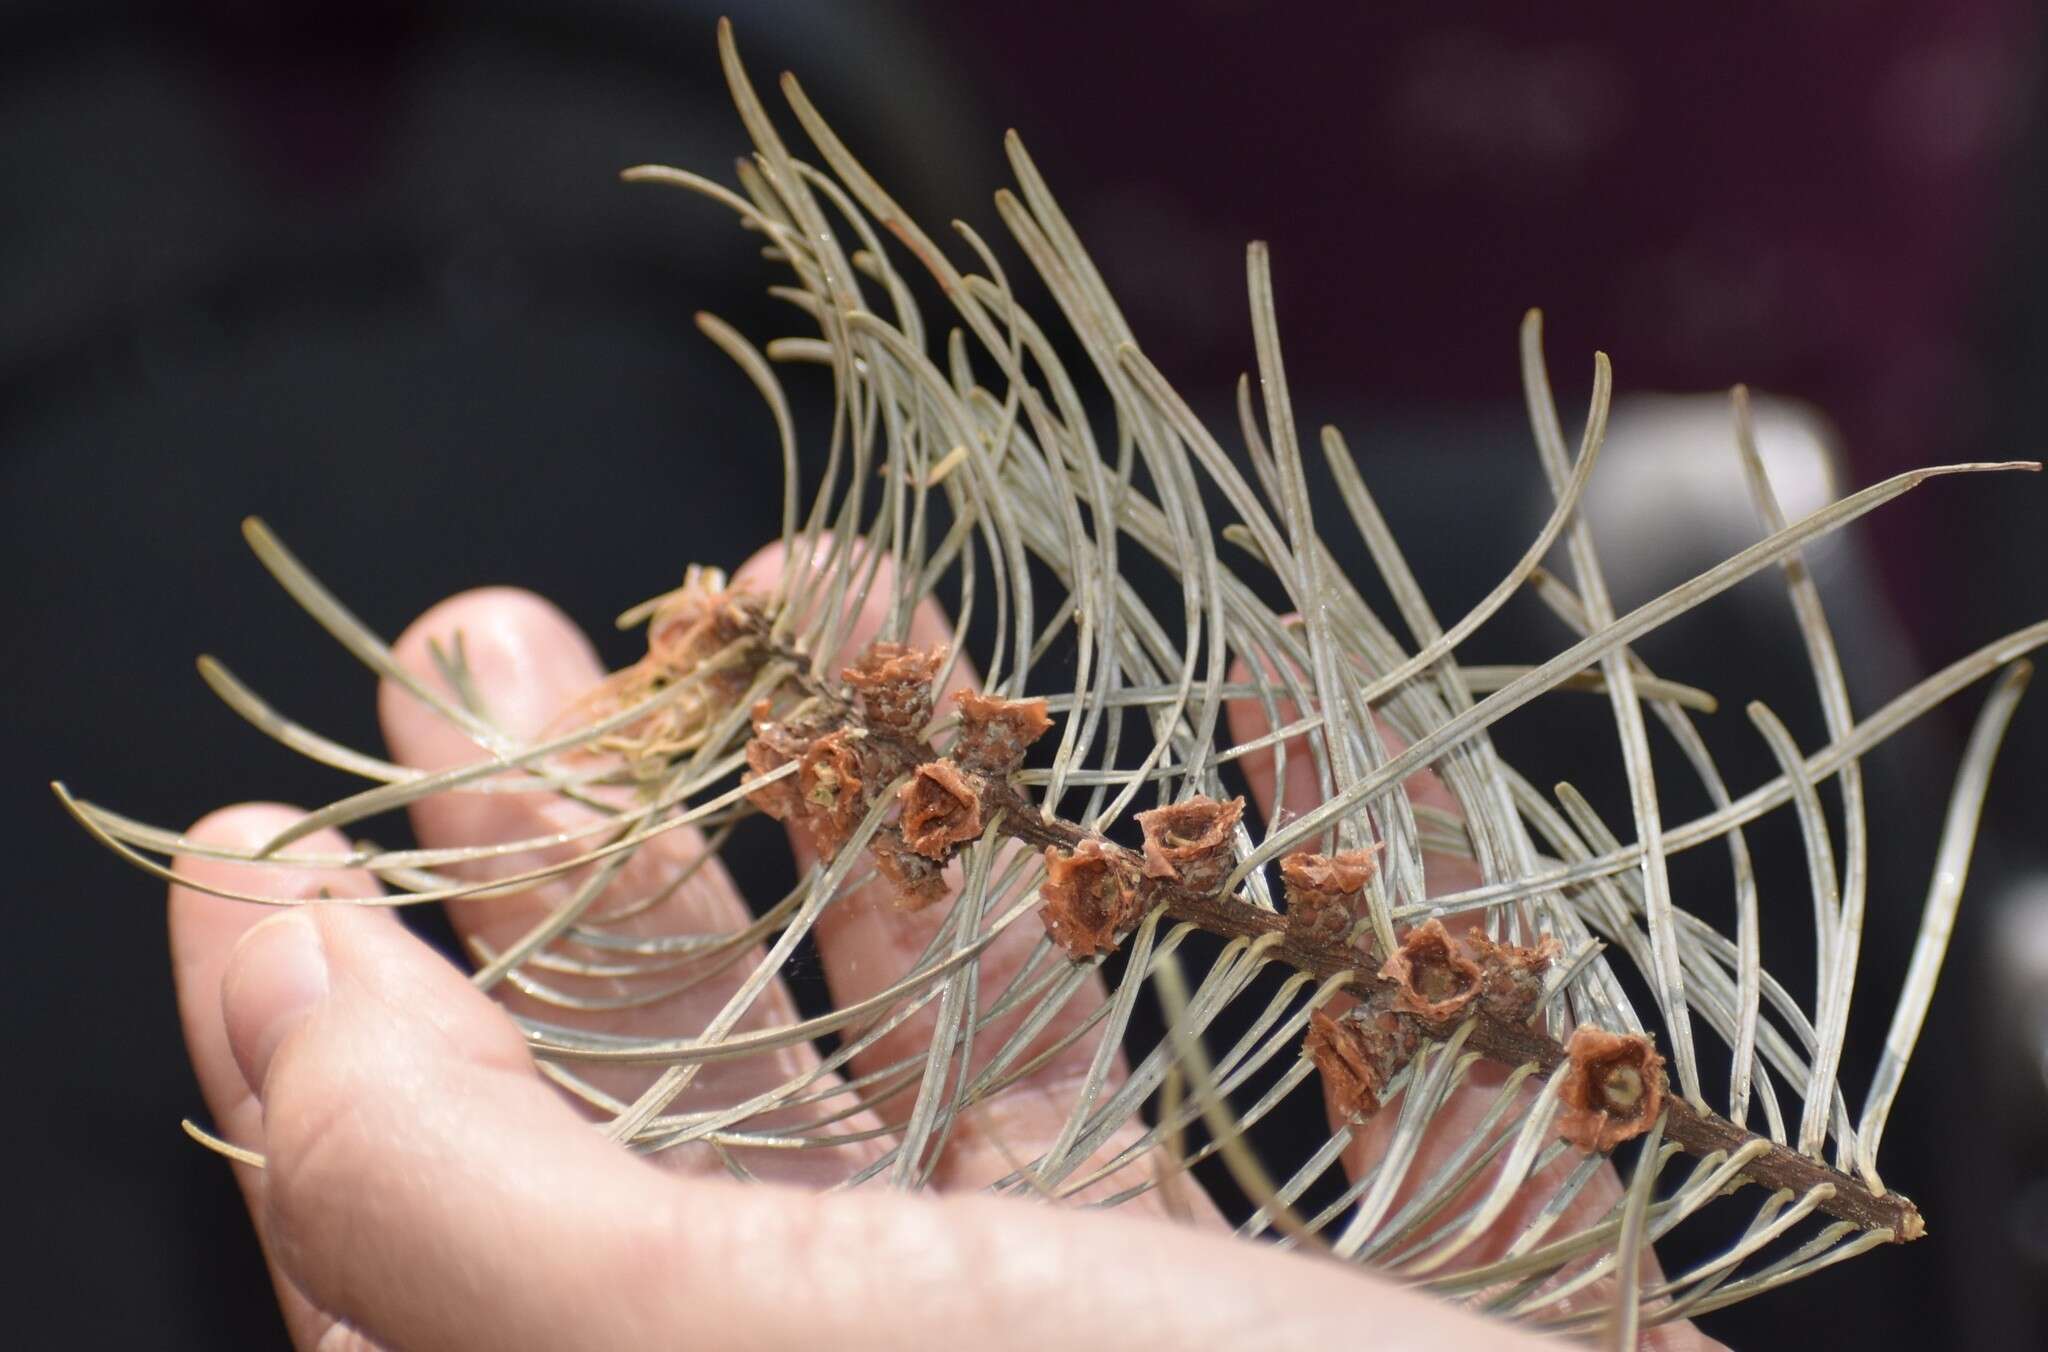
[{"left": 753, "top": 635, "right": 1927, "bottom": 1243}]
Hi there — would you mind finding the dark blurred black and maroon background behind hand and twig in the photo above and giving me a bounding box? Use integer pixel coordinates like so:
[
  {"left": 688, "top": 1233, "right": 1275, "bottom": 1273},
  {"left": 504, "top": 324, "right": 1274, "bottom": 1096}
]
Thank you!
[{"left": 0, "top": 0, "right": 2048, "bottom": 1348}]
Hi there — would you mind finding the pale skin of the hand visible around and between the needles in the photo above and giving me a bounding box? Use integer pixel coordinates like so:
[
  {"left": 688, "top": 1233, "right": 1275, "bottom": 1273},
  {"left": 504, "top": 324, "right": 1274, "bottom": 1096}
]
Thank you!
[{"left": 170, "top": 551, "right": 1712, "bottom": 1352}]
